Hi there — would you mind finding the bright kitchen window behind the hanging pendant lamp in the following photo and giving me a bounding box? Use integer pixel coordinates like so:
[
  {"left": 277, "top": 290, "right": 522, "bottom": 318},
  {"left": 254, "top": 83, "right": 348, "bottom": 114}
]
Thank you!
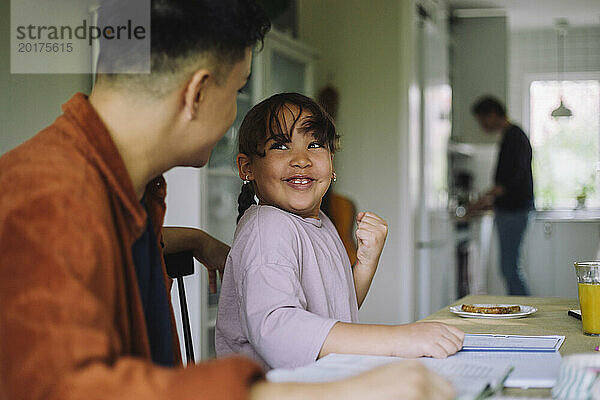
[{"left": 529, "top": 80, "right": 600, "bottom": 209}]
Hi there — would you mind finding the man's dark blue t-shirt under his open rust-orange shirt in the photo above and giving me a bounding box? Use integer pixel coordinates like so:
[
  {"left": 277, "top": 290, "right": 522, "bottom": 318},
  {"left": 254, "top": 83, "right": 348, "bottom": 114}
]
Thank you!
[{"left": 131, "top": 200, "right": 174, "bottom": 367}]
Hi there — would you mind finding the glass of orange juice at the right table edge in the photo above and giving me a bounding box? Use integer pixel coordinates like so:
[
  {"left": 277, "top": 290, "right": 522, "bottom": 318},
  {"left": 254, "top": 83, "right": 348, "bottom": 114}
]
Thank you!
[{"left": 575, "top": 261, "right": 600, "bottom": 336}]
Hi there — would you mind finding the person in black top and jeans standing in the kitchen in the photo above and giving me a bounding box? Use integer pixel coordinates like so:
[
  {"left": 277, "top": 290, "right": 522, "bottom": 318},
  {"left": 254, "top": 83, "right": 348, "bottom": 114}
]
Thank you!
[{"left": 469, "top": 96, "right": 534, "bottom": 296}]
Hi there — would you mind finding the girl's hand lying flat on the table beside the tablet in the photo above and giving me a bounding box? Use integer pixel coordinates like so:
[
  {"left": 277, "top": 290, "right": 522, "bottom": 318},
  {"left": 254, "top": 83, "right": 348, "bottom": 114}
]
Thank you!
[{"left": 393, "top": 322, "right": 465, "bottom": 358}]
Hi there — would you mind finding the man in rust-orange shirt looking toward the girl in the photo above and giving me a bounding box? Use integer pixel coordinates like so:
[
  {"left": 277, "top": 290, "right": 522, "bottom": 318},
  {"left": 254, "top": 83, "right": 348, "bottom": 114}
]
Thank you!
[{"left": 0, "top": 0, "right": 452, "bottom": 400}]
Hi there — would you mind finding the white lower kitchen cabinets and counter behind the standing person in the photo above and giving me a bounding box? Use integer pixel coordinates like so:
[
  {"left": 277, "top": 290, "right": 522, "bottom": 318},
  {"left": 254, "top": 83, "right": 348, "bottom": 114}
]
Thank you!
[{"left": 456, "top": 209, "right": 600, "bottom": 298}]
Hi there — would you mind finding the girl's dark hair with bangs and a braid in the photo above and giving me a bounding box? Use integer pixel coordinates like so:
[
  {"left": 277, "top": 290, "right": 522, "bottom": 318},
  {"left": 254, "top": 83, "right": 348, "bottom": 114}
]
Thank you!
[{"left": 237, "top": 93, "right": 339, "bottom": 222}]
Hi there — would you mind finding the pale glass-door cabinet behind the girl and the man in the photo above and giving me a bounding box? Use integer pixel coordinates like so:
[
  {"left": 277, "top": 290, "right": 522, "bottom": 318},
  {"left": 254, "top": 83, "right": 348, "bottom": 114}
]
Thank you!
[{"left": 165, "top": 30, "right": 317, "bottom": 360}]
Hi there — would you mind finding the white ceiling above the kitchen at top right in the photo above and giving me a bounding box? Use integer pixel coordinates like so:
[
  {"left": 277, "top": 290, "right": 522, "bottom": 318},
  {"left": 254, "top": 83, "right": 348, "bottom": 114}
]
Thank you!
[{"left": 449, "top": 0, "right": 600, "bottom": 30}]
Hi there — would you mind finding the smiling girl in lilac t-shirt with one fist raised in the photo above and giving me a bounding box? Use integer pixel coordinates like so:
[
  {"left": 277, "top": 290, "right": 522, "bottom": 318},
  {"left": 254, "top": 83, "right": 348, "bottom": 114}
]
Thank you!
[{"left": 215, "top": 93, "right": 464, "bottom": 369}]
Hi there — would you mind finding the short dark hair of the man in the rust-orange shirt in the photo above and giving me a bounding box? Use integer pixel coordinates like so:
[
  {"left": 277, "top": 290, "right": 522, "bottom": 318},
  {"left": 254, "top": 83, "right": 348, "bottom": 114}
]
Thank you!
[{"left": 98, "top": 0, "right": 271, "bottom": 94}]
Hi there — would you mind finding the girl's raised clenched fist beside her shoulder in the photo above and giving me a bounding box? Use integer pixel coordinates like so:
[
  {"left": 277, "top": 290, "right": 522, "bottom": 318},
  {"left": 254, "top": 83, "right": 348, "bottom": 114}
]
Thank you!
[{"left": 356, "top": 212, "right": 387, "bottom": 269}]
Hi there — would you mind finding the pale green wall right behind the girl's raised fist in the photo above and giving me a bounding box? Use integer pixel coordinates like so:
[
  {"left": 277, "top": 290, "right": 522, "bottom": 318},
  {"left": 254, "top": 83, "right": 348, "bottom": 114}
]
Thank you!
[{"left": 298, "top": 0, "right": 418, "bottom": 323}]
